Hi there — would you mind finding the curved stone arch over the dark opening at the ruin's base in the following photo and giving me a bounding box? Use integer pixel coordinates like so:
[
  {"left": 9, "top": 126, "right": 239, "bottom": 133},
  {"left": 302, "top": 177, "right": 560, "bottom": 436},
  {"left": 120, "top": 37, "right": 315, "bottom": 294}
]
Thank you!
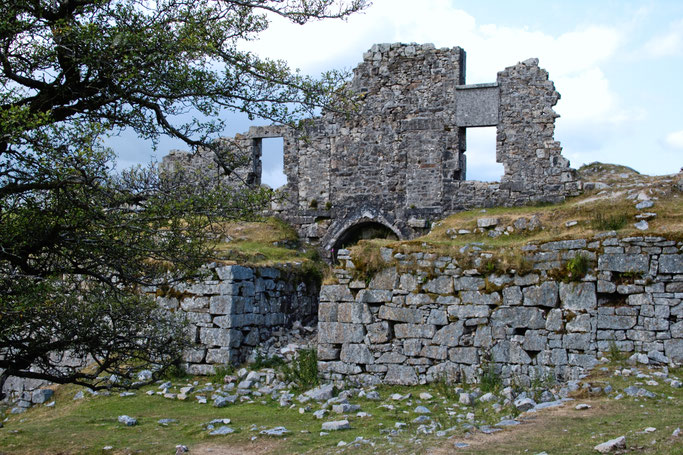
[{"left": 321, "top": 208, "right": 410, "bottom": 258}]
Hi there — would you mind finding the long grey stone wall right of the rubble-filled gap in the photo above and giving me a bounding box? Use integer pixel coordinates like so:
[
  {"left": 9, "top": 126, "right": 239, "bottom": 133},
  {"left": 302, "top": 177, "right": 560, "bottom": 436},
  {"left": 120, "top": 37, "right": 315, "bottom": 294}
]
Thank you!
[{"left": 318, "top": 235, "right": 683, "bottom": 384}]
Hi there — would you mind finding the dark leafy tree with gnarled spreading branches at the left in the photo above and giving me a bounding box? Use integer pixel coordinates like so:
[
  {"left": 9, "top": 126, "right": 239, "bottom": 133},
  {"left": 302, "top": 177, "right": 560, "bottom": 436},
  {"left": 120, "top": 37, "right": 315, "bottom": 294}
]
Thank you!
[{"left": 0, "top": 0, "right": 366, "bottom": 400}]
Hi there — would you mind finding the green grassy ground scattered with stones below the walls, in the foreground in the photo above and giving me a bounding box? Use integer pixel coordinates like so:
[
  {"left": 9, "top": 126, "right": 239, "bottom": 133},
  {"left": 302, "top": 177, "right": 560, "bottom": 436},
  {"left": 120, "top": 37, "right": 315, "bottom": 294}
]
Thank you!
[{"left": 0, "top": 366, "right": 683, "bottom": 455}]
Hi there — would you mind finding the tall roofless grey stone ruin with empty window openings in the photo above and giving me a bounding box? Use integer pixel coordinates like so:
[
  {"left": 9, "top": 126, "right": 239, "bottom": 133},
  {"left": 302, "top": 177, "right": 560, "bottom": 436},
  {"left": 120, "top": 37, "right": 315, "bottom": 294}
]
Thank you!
[{"left": 162, "top": 43, "right": 581, "bottom": 255}]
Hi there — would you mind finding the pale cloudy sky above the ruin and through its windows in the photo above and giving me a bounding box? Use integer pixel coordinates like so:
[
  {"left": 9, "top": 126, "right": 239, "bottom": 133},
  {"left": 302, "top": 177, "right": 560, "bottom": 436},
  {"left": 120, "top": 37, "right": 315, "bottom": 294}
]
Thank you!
[{"left": 110, "top": 0, "right": 683, "bottom": 187}]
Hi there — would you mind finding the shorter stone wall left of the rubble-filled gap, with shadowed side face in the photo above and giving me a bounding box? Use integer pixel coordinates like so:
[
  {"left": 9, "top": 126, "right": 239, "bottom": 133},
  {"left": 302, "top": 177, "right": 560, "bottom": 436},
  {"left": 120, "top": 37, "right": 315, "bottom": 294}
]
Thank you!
[{"left": 156, "top": 265, "right": 320, "bottom": 374}]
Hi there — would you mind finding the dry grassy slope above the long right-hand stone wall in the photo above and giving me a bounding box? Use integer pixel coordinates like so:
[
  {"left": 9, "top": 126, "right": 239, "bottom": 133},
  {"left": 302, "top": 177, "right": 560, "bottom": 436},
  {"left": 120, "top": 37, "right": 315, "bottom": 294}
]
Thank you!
[{"left": 351, "top": 167, "right": 683, "bottom": 268}]
